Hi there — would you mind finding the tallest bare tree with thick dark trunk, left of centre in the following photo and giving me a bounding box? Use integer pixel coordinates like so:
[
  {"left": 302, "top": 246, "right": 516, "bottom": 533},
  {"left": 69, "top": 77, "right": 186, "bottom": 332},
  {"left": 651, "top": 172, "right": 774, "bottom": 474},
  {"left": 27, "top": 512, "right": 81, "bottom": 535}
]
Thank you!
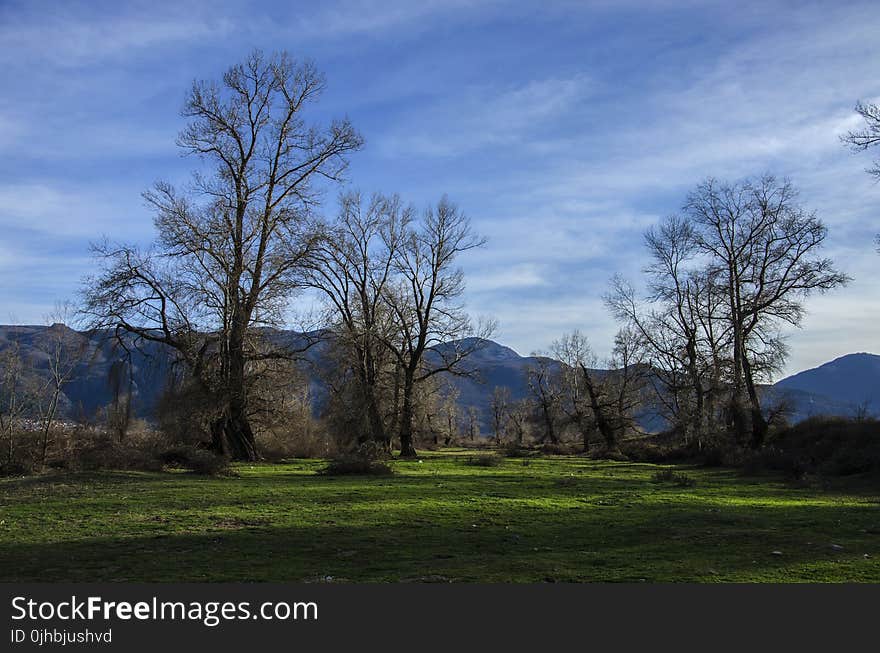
[{"left": 84, "top": 51, "right": 362, "bottom": 460}]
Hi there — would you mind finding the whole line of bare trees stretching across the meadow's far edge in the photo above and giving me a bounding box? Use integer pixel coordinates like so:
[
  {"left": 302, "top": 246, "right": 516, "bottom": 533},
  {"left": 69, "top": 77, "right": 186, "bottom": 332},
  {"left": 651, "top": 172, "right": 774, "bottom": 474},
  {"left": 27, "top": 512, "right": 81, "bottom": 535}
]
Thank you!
[{"left": 0, "top": 51, "right": 873, "bottom": 472}]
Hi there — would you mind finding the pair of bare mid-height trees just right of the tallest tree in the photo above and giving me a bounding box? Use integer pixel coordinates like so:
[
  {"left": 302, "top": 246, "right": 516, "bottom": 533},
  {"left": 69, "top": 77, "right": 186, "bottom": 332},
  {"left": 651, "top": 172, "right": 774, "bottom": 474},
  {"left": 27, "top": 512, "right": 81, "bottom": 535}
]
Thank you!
[{"left": 307, "top": 194, "right": 493, "bottom": 457}]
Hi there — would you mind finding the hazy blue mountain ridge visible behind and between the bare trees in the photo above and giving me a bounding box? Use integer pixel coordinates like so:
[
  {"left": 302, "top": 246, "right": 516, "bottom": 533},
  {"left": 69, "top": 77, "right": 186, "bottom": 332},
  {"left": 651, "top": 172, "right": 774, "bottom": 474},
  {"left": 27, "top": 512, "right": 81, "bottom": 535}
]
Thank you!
[{"left": 0, "top": 325, "right": 880, "bottom": 430}]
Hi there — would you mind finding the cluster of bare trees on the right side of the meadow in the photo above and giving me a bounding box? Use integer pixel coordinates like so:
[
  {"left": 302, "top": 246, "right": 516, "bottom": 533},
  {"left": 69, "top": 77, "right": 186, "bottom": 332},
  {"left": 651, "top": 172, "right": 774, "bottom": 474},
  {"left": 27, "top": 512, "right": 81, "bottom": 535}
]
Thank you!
[{"left": 606, "top": 176, "right": 849, "bottom": 447}]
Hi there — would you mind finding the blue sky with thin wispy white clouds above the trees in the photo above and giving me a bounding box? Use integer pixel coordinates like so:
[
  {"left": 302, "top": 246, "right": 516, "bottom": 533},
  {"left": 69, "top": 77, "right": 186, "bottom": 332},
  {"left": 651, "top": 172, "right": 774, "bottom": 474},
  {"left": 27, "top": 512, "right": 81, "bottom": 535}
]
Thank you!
[{"left": 0, "top": 0, "right": 880, "bottom": 371}]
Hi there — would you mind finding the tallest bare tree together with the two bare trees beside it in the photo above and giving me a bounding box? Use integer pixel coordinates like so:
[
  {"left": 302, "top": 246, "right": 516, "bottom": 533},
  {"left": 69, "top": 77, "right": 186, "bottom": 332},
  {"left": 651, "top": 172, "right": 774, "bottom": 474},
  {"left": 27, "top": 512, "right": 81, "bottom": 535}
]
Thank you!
[{"left": 84, "top": 52, "right": 491, "bottom": 460}]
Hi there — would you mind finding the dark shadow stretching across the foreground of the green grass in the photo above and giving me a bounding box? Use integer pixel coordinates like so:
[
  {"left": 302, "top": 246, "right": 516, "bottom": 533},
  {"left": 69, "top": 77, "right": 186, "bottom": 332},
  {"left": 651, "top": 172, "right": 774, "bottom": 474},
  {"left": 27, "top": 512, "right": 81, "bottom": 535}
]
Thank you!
[{"left": 0, "top": 502, "right": 880, "bottom": 582}]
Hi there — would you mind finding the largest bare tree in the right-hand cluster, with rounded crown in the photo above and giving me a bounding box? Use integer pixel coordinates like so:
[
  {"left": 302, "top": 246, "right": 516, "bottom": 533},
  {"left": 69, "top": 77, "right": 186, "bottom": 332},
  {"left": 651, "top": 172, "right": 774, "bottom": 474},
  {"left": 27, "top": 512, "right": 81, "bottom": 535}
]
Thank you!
[{"left": 685, "top": 175, "right": 849, "bottom": 447}]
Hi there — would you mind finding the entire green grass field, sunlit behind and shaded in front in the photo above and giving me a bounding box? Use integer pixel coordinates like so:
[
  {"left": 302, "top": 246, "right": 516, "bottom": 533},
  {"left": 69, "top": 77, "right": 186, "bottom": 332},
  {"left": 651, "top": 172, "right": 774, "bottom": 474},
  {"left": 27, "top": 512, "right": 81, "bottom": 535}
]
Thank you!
[{"left": 0, "top": 451, "right": 880, "bottom": 582}]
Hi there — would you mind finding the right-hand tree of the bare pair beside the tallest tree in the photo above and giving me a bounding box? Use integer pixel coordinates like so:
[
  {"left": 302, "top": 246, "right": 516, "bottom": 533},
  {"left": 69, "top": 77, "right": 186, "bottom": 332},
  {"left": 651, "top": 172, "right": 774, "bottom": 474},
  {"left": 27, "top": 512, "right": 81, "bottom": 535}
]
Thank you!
[{"left": 383, "top": 197, "right": 494, "bottom": 457}]
